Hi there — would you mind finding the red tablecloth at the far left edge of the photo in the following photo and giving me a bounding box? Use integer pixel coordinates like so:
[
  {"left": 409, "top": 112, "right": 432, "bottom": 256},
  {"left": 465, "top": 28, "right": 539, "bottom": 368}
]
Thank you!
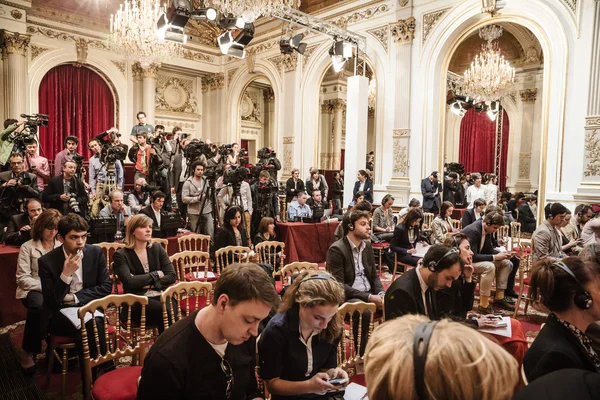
[{"left": 0, "top": 244, "right": 27, "bottom": 327}]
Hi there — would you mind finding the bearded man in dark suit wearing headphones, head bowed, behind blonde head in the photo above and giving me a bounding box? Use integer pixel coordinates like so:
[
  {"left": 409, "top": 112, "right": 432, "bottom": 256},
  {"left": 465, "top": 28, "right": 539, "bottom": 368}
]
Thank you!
[{"left": 385, "top": 244, "right": 461, "bottom": 321}]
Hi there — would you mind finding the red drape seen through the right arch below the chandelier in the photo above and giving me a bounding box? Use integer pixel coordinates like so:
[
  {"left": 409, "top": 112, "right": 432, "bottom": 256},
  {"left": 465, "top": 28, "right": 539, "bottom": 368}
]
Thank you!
[{"left": 458, "top": 108, "right": 509, "bottom": 190}]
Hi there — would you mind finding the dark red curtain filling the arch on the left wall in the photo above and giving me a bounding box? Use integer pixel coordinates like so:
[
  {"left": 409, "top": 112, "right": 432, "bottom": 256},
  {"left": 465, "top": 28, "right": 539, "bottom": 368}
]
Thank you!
[{"left": 39, "top": 65, "right": 115, "bottom": 159}]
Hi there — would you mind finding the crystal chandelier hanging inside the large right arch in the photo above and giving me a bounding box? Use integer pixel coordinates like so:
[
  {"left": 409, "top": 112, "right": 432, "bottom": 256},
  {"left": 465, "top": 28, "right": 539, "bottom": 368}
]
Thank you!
[{"left": 455, "top": 25, "right": 515, "bottom": 103}]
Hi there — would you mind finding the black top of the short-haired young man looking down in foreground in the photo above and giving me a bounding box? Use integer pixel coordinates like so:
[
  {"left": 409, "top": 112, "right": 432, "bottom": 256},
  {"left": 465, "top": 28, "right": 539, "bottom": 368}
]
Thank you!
[{"left": 137, "top": 311, "right": 261, "bottom": 400}]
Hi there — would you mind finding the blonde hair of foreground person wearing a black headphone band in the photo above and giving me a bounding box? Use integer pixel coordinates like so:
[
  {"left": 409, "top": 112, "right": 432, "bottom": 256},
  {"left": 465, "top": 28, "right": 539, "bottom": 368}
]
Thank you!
[{"left": 365, "top": 315, "right": 519, "bottom": 400}]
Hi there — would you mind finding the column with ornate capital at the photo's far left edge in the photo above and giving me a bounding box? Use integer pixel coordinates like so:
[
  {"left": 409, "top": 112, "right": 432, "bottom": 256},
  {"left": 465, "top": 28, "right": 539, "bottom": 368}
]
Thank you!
[{"left": 0, "top": 30, "right": 31, "bottom": 118}]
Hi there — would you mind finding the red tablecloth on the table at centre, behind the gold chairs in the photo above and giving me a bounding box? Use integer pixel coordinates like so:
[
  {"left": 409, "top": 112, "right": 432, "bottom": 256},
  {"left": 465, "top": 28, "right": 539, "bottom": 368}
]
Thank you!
[{"left": 277, "top": 221, "right": 339, "bottom": 263}]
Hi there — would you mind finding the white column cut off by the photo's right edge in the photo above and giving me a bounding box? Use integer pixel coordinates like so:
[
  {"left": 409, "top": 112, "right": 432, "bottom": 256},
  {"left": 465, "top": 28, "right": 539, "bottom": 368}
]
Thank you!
[{"left": 573, "top": 0, "right": 600, "bottom": 203}]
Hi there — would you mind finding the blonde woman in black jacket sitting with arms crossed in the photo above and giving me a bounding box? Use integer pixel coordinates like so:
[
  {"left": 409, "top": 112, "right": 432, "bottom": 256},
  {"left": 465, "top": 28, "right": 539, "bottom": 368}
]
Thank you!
[{"left": 113, "top": 214, "right": 177, "bottom": 332}]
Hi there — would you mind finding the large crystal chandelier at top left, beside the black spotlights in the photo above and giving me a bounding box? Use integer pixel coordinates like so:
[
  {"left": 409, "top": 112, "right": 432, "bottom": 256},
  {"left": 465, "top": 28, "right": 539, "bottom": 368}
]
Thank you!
[{"left": 109, "top": 0, "right": 181, "bottom": 68}]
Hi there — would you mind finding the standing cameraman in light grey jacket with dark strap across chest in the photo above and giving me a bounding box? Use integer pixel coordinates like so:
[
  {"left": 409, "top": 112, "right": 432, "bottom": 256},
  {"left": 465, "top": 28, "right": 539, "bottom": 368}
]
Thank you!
[{"left": 181, "top": 160, "right": 215, "bottom": 238}]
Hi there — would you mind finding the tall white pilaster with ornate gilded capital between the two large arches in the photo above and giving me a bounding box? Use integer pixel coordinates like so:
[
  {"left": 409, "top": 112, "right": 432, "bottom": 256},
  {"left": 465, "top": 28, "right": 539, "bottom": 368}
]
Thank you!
[{"left": 386, "top": 17, "right": 415, "bottom": 204}]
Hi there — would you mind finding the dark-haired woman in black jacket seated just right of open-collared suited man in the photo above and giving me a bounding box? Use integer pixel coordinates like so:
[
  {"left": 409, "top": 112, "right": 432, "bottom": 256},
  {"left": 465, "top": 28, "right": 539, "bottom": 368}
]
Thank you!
[{"left": 390, "top": 209, "right": 423, "bottom": 267}]
